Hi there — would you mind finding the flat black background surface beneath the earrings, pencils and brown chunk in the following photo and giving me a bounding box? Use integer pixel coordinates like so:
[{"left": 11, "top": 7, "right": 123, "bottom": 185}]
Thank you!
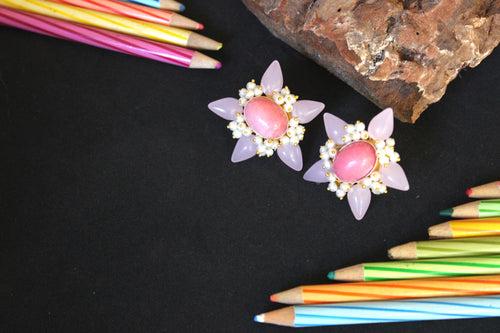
[{"left": 0, "top": 0, "right": 500, "bottom": 332}]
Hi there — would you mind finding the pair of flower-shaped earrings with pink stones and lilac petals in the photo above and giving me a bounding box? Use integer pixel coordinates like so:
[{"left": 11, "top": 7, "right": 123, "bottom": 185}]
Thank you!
[{"left": 208, "top": 61, "right": 409, "bottom": 220}]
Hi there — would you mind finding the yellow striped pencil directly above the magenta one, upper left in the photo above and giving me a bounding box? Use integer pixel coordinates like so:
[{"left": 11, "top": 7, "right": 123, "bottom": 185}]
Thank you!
[{"left": 0, "top": 0, "right": 222, "bottom": 50}]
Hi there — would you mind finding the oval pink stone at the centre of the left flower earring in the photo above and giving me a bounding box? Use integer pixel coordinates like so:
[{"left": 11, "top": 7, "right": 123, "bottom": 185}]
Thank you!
[{"left": 243, "top": 96, "right": 288, "bottom": 139}]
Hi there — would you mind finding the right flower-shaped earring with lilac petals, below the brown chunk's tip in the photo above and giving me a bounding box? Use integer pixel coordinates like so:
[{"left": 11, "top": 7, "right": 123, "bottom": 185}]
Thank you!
[{"left": 304, "top": 108, "right": 410, "bottom": 220}]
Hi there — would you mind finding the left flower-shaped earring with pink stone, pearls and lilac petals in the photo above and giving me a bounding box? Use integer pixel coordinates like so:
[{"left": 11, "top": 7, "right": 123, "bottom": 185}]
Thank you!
[{"left": 208, "top": 61, "right": 325, "bottom": 171}]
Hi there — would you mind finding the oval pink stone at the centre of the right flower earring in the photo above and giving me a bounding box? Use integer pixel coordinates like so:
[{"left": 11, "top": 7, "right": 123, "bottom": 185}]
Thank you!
[{"left": 332, "top": 141, "right": 377, "bottom": 182}]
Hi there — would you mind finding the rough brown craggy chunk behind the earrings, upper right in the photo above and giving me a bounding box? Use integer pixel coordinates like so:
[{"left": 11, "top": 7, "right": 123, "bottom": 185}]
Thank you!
[{"left": 243, "top": 0, "right": 500, "bottom": 122}]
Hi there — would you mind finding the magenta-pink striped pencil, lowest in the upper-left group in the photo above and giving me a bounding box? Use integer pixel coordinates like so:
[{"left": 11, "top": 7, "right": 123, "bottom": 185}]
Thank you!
[{"left": 0, "top": 7, "right": 221, "bottom": 68}]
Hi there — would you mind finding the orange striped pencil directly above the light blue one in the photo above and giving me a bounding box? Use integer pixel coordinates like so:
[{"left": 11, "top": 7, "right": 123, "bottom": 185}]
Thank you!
[{"left": 271, "top": 275, "right": 500, "bottom": 304}]
